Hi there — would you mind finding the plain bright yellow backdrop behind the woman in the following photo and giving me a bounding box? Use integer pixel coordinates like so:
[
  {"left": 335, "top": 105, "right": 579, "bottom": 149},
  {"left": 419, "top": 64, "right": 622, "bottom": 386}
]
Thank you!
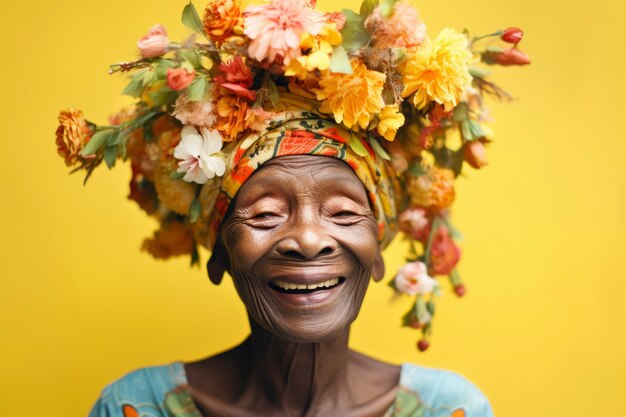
[{"left": 0, "top": 0, "right": 626, "bottom": 417}]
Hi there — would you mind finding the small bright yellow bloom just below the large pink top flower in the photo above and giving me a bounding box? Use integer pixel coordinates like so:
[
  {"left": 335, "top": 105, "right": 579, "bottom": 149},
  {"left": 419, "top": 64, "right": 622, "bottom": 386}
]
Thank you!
[{"left": 285, "top": 23, "right": 342, "bottom": 80}]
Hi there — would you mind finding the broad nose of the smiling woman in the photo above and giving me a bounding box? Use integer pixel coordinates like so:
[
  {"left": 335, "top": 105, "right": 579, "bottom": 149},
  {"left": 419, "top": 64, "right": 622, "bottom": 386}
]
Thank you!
[{"left": 276, "top": 222, "right": 337, "bottom": 259}]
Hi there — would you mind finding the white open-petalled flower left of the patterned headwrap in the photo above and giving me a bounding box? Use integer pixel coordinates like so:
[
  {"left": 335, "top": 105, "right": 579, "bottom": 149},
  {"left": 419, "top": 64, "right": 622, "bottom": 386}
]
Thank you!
[{"left": 174, "top": 125, "right": 226, "bottom": 184}]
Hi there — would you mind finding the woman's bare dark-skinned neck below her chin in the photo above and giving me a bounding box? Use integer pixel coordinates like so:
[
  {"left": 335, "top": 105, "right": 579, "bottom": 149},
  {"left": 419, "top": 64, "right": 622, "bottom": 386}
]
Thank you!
[{"left": 246, "top": 320, "right": 349, "bottom": 415}]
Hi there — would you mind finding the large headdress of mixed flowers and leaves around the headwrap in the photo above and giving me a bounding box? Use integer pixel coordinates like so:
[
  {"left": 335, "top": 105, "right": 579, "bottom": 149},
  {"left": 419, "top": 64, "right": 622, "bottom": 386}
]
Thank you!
[{"left": 56, "top": 0, "right": 529, "bottom": 351}]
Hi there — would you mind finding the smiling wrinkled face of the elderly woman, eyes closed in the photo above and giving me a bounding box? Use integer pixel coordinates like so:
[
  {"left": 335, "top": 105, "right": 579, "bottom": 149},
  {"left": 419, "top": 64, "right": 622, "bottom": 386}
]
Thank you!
[{"left": 221, "top": 156, "right": 383, "bottom": 342}]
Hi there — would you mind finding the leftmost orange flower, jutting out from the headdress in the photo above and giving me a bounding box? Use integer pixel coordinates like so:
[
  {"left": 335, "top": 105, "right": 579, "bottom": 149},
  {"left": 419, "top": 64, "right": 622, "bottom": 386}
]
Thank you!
[{"left": 56, "top": 109, "right": 93, "bottom": 167}]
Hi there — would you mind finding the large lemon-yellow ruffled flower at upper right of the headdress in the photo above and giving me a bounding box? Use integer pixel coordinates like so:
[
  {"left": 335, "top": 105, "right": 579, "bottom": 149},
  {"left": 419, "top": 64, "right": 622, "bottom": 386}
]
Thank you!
[{"left": 398, "top": 29, "right": 472, "bottom": 111}]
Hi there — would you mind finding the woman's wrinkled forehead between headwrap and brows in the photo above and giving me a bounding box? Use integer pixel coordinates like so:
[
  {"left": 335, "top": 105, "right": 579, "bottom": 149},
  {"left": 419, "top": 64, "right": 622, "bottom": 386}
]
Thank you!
[{"left": 237, "top": 155, "right": 367, "bottom": 200}]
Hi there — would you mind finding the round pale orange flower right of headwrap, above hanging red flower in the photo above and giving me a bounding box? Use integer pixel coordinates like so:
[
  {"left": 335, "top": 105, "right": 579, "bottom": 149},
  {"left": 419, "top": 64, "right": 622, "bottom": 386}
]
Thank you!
[{"left": 408, "top": 167, "right": 455, "bottom": 211}]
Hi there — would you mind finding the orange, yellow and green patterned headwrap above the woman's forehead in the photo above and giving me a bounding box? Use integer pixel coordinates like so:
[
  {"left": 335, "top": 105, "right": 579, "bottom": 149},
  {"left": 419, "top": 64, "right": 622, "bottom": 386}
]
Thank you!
[{"left": 207, "top": 110, "right": 397, "bottom": 249}]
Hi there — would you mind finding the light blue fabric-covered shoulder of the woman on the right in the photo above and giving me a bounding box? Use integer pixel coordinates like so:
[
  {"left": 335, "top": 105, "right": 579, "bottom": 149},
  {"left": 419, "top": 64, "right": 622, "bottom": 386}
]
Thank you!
[{"left": 400, "top": 363, "right": 493, "bottom": 417}]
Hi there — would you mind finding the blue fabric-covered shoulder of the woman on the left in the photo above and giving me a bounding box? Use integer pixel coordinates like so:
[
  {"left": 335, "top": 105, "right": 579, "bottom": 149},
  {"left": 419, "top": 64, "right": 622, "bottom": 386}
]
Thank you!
[{"left": 89, "top": 362, "right": 186, "bottom": 417}]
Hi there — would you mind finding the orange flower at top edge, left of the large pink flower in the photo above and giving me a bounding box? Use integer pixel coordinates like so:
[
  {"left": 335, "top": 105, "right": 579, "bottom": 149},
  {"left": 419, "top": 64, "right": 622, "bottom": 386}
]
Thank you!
[{"left": 203, "top": 0, "right": 243, "bottom": 45}]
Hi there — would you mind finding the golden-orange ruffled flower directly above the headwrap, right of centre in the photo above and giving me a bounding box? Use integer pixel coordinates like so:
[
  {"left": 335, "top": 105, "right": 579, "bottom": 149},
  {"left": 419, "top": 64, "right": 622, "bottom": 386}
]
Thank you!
[{"left": 313, "top": 59, "right": 386, "bottom": 129}]
